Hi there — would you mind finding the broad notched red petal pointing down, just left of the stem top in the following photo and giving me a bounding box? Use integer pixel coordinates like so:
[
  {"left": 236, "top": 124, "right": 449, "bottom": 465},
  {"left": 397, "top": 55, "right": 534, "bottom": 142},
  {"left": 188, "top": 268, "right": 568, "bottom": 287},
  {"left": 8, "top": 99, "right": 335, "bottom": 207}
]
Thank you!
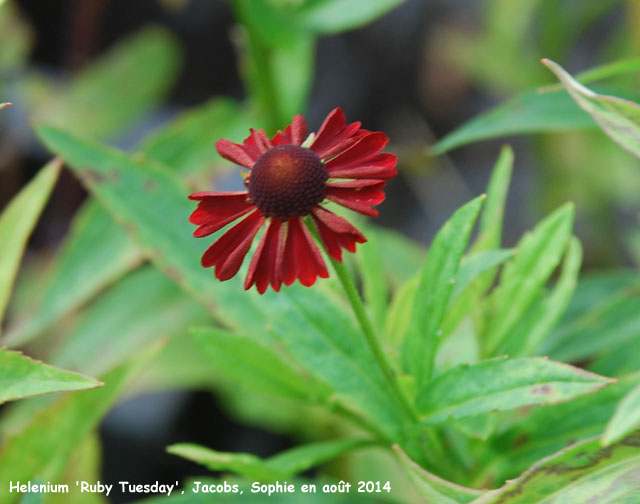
[{"left": 281, "top": 218, "right": 329, "bottom": 287}]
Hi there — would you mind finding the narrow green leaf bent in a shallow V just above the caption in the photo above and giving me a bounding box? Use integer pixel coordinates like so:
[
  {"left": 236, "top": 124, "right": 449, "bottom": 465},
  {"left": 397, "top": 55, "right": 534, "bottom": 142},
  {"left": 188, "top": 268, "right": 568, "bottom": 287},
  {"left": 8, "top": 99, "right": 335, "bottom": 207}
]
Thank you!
[{"left": 167, "top": 439, "right": 373, "bottom": 481}]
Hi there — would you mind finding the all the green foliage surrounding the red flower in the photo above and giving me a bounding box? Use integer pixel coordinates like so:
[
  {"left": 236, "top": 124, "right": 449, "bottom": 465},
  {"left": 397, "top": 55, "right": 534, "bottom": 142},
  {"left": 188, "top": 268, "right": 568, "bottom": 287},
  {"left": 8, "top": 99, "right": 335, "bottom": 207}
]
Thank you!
[{"left": 0, "top": 0, "right": 640, "bottom": 504}]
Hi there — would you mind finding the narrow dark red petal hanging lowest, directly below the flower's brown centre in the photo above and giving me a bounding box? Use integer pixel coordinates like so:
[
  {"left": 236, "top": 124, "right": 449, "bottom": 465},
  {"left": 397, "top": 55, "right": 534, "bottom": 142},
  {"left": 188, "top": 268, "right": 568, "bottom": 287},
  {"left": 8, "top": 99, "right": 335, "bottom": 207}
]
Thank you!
[{"left": 244, "top": 219, "right": 284, "bottom": 294}]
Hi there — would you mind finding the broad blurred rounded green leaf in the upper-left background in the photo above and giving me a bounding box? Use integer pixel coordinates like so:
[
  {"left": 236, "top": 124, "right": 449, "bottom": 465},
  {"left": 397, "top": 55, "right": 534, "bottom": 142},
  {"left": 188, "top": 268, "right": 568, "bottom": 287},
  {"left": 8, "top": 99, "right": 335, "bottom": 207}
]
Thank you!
[{"left": 31, "top": 28, "right": 179, "bottom": 137}]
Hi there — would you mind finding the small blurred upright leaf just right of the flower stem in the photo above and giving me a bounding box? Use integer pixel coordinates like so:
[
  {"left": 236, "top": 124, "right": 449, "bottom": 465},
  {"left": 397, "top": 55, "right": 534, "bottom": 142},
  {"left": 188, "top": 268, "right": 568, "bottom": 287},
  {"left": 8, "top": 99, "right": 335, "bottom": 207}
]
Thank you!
[{"left": 356, "top": 232, "right": 389, "bottom": 327}]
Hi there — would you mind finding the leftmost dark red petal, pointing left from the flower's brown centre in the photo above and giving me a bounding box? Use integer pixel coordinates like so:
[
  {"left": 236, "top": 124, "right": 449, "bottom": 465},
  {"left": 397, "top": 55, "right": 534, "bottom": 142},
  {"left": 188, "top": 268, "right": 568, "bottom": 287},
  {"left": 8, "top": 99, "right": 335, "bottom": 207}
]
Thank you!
[{"left": 189, "top": 191, "right": 255, "bottom": 238}]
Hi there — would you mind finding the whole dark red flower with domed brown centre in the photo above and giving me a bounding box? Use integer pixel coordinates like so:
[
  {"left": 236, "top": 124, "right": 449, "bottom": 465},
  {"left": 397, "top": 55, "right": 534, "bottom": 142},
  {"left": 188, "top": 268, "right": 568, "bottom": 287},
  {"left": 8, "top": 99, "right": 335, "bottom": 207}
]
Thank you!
[{"left": 189, "top": 108, "right": 397, "bottom": 294}]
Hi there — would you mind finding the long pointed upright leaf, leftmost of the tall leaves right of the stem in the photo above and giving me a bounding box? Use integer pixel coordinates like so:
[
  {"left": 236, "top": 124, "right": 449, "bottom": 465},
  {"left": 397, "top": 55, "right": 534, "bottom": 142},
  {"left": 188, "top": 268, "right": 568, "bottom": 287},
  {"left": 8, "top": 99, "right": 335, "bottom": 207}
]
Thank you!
[{"left": 402, "top": 196, "right": 485, "bottom": 386}]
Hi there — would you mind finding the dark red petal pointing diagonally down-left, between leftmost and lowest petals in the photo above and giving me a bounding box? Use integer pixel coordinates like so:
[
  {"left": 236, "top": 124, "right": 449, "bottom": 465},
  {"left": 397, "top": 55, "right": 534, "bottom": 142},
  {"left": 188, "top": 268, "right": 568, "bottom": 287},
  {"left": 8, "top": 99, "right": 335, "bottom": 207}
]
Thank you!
[{"left": 201, "top": 210, "right": 265, "bottom": 281}]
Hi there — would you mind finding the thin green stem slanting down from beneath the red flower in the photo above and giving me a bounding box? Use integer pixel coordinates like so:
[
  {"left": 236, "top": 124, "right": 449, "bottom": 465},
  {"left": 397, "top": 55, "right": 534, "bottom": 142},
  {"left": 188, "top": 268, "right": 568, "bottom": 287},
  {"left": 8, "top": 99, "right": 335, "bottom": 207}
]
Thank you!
[{"left": 331, "top": 258, "right": 418, "bottom": 422}]
